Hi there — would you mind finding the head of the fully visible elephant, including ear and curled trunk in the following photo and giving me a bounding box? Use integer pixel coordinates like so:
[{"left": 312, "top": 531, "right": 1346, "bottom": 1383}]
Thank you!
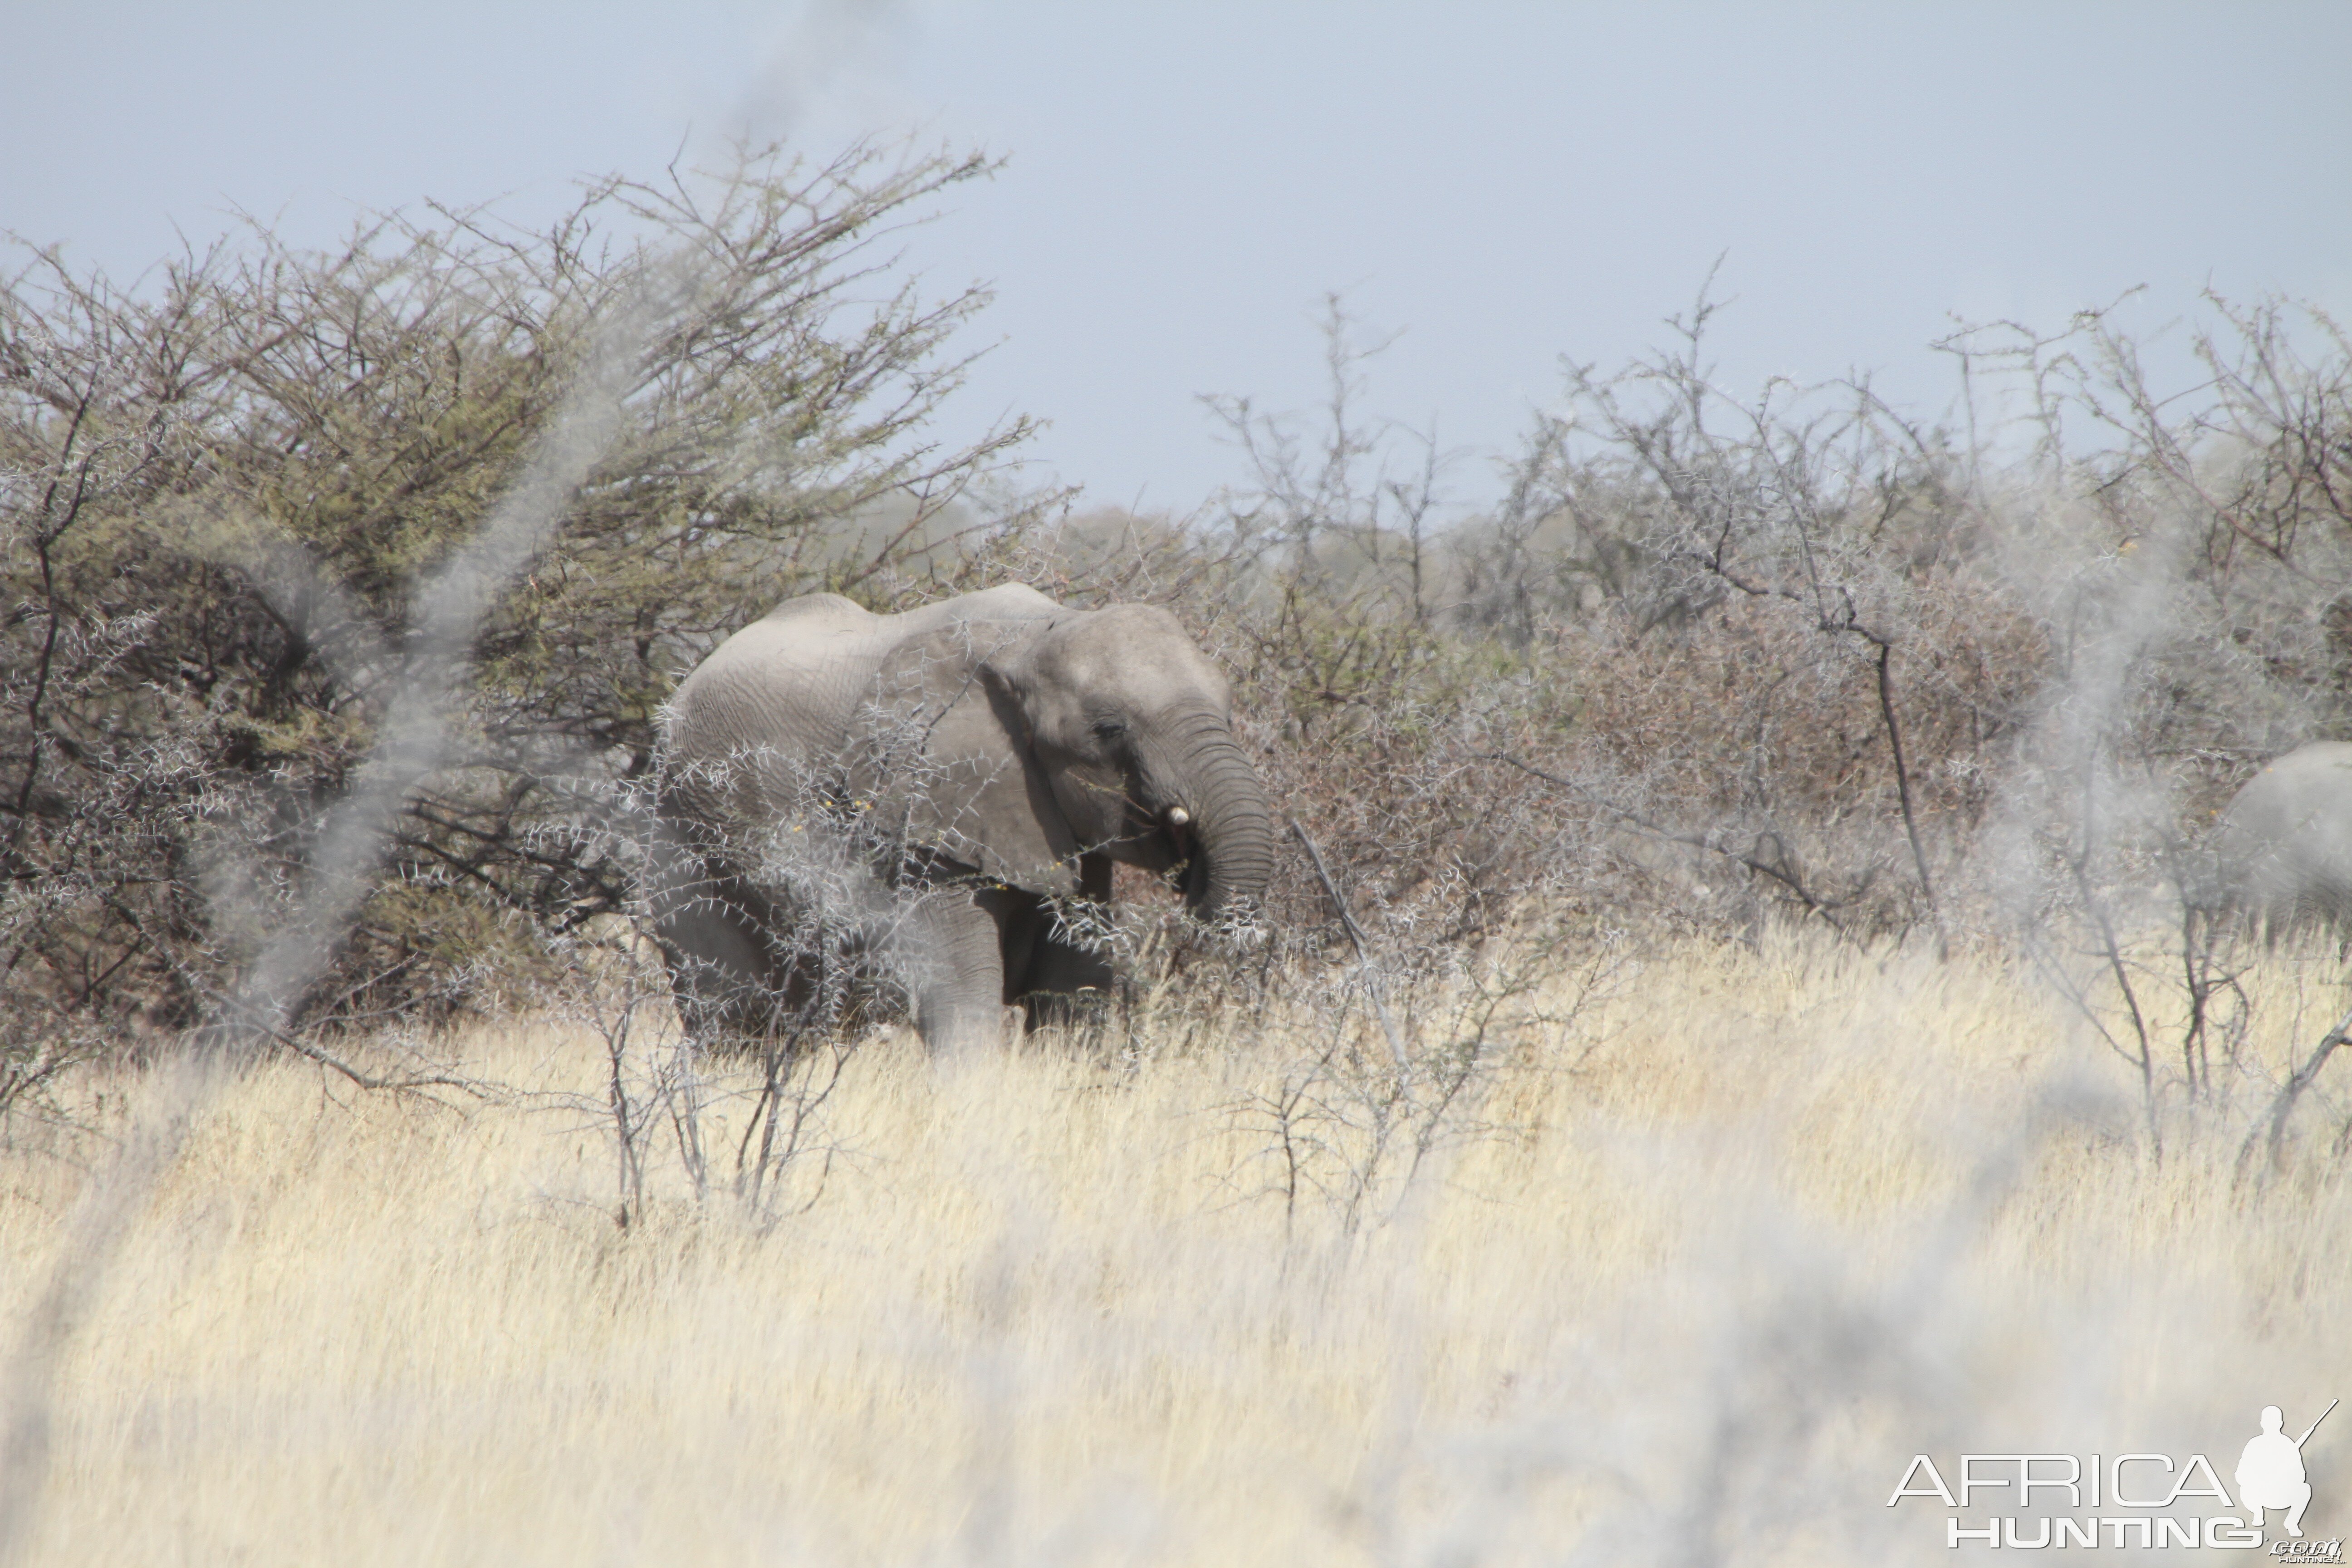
[{"left": 856, "top": 599, "right": 1275, "bottom": 919}]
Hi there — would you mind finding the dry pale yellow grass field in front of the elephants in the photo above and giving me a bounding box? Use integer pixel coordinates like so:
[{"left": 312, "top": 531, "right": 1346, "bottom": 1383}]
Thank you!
[{"left": 0, "top": 943, "right": 2352, "bottom": 1566}]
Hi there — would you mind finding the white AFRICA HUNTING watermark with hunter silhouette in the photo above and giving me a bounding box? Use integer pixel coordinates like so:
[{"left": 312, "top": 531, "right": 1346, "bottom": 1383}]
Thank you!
[{"left": 1886, "top": 1399, "right": 2342, "bottom": 1563}]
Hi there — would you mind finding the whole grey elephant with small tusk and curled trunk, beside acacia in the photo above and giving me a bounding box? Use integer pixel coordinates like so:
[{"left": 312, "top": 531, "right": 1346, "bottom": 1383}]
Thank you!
[{"left": 649, "top": 583, "right": 1275, "bottom": 1051}]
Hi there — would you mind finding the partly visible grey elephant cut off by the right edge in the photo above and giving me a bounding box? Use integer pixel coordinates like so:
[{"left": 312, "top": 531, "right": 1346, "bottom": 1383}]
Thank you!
[{"left": 2213, "top": 740, "right": 2352, "bottom": 936}]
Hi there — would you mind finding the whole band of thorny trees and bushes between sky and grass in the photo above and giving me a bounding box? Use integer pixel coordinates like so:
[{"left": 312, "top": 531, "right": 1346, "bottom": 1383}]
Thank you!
[{"left": 0, "top": 138, "right": 2352, "bottom": 1102}]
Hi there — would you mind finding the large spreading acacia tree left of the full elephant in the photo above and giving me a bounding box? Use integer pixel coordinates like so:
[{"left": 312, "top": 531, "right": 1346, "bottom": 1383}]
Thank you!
[{"left": 0, "top": 146, "right": 1049, "bottom": 1081}]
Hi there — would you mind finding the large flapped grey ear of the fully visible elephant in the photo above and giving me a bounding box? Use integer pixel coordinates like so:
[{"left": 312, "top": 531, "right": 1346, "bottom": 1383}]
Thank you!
[{"left": 852, "top": 621, "right": 1079, "bottom": 893}]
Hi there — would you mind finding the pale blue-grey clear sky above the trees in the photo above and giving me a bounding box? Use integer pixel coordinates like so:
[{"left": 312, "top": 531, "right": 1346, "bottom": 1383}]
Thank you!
[{"left": 0, "top": 0, "right": 2352, "bottom": 510}]
